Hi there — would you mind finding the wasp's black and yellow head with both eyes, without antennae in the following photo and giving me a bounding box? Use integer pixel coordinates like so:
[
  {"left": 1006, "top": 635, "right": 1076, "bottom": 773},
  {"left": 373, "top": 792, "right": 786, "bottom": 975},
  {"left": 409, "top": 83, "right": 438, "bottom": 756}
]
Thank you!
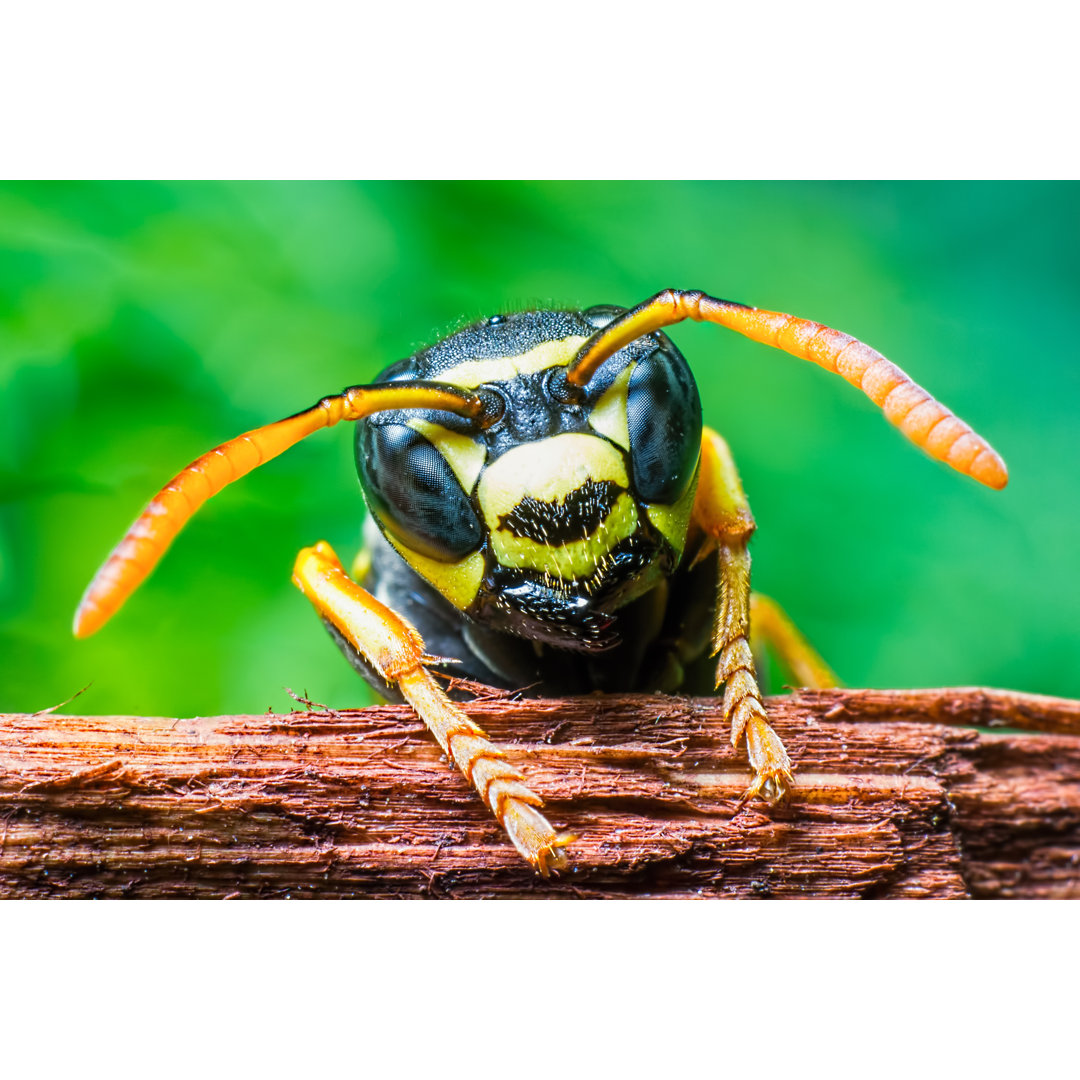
[{"left": 356, "top": 308, "right": 701, "bottom": 651}]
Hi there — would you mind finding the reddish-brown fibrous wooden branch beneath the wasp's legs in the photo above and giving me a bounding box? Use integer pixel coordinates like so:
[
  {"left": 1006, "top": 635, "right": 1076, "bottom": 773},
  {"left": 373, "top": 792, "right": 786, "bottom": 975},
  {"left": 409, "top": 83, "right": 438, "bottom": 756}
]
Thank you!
[{"left": 0, "top": 689, "right": 1080, "bottom": 896}]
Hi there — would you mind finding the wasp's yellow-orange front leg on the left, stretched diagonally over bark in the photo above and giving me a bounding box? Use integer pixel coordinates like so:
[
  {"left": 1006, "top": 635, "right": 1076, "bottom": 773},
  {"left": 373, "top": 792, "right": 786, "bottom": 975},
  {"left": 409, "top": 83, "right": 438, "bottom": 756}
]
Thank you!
[{"left": 293, "top": 542, "right": 573, "bottom": 877}]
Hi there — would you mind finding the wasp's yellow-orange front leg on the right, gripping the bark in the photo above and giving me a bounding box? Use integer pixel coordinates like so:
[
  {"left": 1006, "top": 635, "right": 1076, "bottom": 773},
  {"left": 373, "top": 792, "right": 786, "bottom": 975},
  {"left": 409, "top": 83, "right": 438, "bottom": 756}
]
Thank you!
[{"left": 693, "top": 428, "right": 794, "bottom": 804}]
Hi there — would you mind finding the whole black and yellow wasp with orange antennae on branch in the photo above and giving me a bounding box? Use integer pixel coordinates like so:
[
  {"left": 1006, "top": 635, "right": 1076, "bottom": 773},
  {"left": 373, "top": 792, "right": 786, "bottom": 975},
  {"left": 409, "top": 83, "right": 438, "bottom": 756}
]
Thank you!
[{"left": 75, "top": 289, "right": 1008, "bottom": 875}]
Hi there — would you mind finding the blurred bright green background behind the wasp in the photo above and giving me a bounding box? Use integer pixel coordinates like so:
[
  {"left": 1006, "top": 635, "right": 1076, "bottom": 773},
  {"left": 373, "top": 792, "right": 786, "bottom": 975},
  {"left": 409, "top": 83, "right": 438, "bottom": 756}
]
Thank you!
[{"left": 0, "top": 183, "right": 1080, "bottom": 715}]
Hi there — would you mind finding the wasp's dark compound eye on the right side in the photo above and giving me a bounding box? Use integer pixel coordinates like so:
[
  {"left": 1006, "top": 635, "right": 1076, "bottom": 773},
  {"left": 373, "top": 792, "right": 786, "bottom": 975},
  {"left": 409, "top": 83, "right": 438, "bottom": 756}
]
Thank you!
[{"left": 626, "top": 349, "right": 701, "bottom": 504}]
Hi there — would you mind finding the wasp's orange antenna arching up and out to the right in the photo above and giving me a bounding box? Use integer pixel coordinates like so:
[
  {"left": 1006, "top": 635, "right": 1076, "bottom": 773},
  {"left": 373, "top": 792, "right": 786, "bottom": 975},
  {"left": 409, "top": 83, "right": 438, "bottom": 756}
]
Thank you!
[{"left": 566, "top": 288, "right": 1009, "bottom": 488}]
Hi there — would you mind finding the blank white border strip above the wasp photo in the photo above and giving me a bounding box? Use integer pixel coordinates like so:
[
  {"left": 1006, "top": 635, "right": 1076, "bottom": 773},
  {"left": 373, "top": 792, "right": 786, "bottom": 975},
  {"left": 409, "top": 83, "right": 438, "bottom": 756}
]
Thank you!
[{"left": 0, "top": 0, "right": 1077, "bottom": 179}]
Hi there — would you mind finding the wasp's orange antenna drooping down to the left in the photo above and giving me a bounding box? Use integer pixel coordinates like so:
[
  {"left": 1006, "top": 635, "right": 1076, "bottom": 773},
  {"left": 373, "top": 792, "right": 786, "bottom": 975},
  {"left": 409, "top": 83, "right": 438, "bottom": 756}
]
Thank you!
[{"left": 72, "top": 382, "right": 485, "bottom": 637}]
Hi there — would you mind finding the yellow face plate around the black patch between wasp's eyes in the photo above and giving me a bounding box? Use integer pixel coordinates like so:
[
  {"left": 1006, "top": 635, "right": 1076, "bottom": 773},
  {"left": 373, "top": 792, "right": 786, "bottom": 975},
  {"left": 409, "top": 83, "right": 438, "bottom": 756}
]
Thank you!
[{"left": 477, "top": 433, "right": 637, "bottom": 581}]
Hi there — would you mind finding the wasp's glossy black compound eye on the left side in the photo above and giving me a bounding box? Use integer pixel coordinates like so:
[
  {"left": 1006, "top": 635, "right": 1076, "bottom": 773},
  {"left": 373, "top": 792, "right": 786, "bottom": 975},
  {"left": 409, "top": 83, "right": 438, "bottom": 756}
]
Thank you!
[{"left": 356, "top": 421, "right": 483, "bottom": 563}]
